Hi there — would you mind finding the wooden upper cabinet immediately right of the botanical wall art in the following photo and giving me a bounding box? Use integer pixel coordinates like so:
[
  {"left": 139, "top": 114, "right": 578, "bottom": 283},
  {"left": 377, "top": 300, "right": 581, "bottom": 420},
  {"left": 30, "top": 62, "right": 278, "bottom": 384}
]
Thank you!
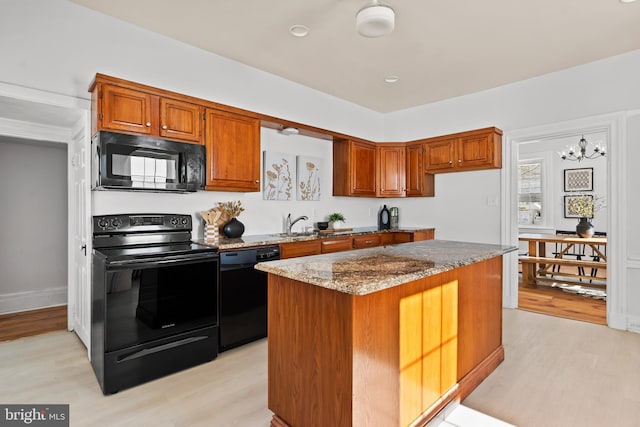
[{"left": 333, "top": 139, "right": 376, "bottom": 197}]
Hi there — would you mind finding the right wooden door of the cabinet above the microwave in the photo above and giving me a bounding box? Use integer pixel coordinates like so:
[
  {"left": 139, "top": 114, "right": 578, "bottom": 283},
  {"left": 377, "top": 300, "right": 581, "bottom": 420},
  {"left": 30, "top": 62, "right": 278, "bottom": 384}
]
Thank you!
[{"left": 160, "top": 98, "right": 203, "bottom": 144}]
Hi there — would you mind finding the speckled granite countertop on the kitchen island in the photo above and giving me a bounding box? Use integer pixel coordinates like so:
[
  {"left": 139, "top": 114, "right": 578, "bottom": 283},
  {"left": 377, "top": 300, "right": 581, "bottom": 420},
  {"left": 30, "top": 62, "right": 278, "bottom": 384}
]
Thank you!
[{"left": 256, "top": 240, "right": 517, "bottom": 295}]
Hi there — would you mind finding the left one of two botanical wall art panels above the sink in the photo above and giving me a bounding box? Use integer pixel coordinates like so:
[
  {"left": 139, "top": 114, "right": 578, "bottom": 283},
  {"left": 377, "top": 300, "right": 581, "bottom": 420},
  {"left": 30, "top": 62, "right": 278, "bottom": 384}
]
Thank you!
[{"left": 262, "top": 151, "right": 295, "bottom": 200}]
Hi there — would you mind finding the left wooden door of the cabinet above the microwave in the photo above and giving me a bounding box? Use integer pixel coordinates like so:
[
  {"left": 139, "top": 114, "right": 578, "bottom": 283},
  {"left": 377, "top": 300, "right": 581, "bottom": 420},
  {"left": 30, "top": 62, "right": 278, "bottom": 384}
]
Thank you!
[{"left": 100, "top": 85, "right": 152, "bottom": 135}]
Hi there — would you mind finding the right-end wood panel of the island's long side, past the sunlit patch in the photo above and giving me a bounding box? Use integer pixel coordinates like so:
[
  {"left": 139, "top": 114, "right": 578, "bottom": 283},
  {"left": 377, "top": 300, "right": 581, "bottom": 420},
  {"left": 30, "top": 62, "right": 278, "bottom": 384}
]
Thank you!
[{"left": 457, "top": 257, "right": 502, "bottom": 381}]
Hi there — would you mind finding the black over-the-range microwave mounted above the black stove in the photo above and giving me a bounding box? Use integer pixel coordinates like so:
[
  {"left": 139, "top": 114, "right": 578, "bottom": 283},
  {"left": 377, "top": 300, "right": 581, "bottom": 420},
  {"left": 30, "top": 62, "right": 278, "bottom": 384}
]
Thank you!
[{"left": 91, "top": 131, "right": 205, "bottom": 192}]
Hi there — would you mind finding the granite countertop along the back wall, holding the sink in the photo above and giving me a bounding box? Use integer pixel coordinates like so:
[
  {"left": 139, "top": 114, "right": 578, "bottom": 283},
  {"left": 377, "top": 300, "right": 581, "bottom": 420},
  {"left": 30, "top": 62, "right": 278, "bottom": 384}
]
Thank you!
[{"left": 194, "top": 227, "right": 433, "bottom": 251}]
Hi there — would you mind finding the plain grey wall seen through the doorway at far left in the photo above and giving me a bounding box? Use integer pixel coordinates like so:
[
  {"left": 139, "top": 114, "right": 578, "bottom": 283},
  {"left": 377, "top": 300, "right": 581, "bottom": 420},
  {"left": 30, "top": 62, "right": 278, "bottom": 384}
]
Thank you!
[{"left": 0, "top": 136, "right": 67, "bottom": 314}]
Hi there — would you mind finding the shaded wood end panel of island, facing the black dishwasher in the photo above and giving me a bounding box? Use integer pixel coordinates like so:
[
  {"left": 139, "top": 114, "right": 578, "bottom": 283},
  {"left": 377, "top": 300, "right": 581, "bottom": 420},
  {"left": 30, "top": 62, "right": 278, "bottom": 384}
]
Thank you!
[{"left": 268, "top": 274, "right": 353, "bottom": 427}]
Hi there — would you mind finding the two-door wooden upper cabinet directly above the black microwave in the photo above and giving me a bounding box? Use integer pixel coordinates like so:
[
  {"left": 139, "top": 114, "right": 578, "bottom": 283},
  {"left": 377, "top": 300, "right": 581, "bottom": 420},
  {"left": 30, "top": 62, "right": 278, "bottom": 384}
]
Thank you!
[{"left": 92, "top": 78, "right": 204, "bottom": 144}]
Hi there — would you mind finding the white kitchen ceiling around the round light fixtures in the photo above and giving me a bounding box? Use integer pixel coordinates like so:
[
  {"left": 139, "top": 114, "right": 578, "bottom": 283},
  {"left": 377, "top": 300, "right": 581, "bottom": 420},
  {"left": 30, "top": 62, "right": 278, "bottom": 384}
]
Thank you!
[{"left": 71, "top": 0, "right": 640, "bottom": 112}]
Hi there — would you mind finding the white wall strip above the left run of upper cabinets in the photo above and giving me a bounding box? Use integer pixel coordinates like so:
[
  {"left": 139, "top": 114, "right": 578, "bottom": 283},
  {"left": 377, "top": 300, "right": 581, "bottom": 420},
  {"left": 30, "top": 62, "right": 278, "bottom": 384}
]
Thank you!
[{"left": 0, "top": 0, "right": 383, "bottom": 140}]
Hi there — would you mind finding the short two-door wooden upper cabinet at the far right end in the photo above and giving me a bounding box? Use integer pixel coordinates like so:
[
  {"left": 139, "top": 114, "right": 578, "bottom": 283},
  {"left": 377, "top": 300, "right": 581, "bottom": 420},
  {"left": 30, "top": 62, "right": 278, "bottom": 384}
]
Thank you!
[{"left": 428, "top": 127, "right": 502, "bottom": 173}]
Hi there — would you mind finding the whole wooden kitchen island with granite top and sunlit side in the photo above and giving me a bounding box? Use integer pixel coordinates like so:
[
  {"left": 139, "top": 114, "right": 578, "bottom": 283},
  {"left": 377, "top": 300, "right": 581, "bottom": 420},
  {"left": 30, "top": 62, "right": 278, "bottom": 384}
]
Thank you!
[{"left": 256, "top": 240, "right": 516, "bottom": 427}]
